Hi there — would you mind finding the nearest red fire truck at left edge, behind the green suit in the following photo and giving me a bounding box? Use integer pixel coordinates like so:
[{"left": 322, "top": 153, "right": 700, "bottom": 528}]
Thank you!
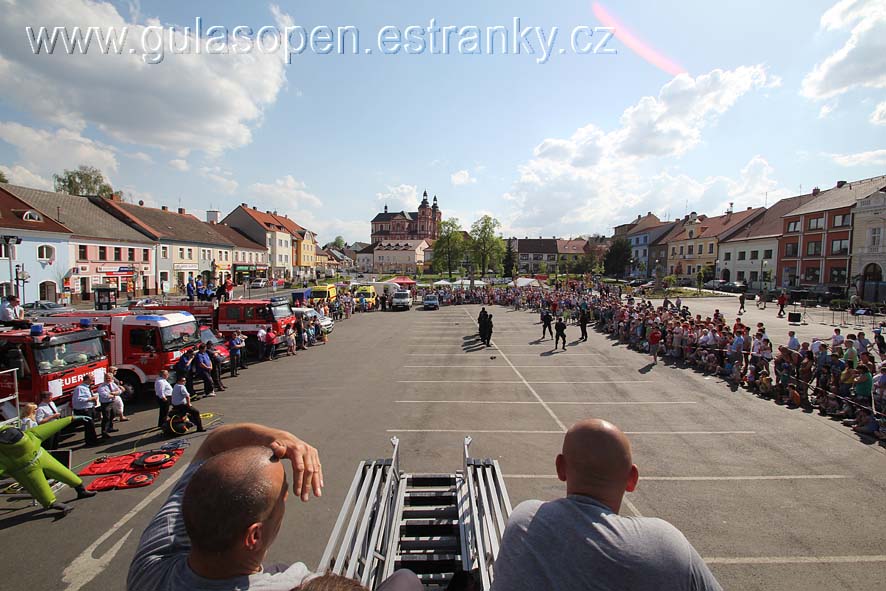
[{"left": 0, "top": 325, "right": 109, "bottom": 418}]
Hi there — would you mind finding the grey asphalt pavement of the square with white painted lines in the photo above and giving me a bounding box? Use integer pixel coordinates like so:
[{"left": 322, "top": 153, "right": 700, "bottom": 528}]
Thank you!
[{"left": 0, "top": 298, "right": 886, "bottom": 591}]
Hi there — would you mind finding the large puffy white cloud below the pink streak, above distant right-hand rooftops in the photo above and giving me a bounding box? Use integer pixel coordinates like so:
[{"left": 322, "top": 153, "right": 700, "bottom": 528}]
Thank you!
[{"left": 500, "top": 66, "right": 779, "bottom": 236}]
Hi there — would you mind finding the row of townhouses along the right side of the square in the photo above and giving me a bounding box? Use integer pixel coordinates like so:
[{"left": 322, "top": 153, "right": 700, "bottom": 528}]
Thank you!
[{"left": 612, "top": 176, "right": 886, "bottom": 300}]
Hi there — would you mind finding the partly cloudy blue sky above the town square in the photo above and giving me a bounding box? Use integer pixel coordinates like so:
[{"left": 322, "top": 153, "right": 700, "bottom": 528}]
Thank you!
[{"left": 0, "top": 0, "right": 886, "bottom": 242}]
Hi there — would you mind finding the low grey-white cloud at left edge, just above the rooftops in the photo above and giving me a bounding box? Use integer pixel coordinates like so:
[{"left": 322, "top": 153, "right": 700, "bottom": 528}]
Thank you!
[{"left": 0, "top": 121, "right": 117, "bottom": 178}]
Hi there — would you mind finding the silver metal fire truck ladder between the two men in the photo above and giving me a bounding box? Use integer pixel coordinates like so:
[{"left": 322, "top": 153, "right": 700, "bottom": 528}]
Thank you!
[{"left": 318, "top": 437, "right": 511, "bottom": 590}]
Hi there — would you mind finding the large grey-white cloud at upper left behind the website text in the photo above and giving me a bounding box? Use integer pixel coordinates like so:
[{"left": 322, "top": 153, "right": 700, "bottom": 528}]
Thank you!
[{"left": 0, "top": 0, "right": 286, "bottom": 157}]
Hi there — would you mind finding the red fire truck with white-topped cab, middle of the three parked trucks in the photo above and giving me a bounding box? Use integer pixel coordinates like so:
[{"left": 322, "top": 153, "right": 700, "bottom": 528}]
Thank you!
[{"left": 32, "top": 310, "right": 200, "bottom": 393}]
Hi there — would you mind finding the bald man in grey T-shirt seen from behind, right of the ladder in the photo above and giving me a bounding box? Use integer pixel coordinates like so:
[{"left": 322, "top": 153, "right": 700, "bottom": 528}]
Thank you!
[{"left": 492, "top": 419, "right": 721, "bottom": 591}]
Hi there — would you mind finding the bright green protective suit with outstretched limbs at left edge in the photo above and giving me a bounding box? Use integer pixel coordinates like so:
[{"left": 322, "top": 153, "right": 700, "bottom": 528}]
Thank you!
[{"left": 0, "top": 417, "right": 83, "bottom": 508}]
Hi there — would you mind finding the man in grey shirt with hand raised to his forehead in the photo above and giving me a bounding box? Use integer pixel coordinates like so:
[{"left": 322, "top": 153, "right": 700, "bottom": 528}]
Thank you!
[{"left": 126, "top": 424, "right": 422, "bottom": 591}]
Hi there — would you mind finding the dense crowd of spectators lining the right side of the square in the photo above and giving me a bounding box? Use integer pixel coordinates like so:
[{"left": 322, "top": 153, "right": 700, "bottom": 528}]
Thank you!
[{"left": 591, "top": 285, "right": 886, "bottom": 439}]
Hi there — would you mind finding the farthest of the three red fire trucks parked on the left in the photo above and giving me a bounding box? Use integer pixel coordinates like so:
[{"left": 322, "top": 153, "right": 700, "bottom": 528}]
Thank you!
[{"left": 130, "top": 297, "right": 296, "bottom": 354}]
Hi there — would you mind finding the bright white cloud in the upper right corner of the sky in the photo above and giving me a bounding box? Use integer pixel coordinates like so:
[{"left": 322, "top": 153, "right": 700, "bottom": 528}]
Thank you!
[{"left": 801, "top": 0, "right": 886, "bottom": 100}]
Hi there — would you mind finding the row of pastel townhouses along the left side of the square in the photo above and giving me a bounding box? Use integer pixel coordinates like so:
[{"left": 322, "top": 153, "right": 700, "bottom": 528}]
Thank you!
[{"left": 0, "top": 183, "right": 351, "bottom": 302}]
